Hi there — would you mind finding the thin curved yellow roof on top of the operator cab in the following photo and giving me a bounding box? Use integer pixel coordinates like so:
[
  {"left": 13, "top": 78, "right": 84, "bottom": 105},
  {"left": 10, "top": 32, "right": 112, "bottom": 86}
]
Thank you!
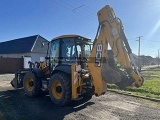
[{"left": 52, "top": 34, "right": 91, "bottom": 41}]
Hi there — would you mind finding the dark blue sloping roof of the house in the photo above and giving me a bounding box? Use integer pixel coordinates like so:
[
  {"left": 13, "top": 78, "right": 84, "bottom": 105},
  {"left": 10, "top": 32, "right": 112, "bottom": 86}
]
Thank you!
[{"left": 0, "top": 35, "right": 44, "bottom": 54}]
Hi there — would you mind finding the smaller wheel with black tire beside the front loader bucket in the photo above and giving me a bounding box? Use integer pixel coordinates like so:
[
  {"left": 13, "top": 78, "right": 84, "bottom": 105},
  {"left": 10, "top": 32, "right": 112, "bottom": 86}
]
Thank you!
[{"left": 23, "top": 72, "right": 42, "bottom": 97}]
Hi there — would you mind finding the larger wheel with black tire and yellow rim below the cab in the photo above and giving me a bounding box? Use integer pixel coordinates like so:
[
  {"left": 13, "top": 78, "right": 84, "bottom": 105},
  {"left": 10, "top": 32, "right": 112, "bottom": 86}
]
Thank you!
[{"left": 48, "top": 73, "right": 71, "bottom": 106}]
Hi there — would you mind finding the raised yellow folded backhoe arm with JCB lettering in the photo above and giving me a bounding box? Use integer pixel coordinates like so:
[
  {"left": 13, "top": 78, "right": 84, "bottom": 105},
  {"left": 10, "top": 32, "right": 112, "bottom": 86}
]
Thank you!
[{"left": 88, "top": 5, "right": 143, "bottom": 96}]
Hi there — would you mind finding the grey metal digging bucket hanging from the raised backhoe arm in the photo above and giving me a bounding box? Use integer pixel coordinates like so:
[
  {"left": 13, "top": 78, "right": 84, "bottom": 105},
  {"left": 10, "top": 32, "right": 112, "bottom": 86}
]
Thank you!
[{"left": 102, "top": 51, "right": 134, "bottom": 89}]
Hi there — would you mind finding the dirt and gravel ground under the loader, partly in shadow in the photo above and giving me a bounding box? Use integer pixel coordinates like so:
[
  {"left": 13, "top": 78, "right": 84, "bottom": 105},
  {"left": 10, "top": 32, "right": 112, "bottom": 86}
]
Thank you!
[{"left": 0, "top": 74, "right": 160, "bottom": 120}]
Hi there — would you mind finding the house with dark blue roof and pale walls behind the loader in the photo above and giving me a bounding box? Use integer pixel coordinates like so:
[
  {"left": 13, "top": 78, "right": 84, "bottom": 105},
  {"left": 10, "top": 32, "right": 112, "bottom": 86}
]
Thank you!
[{"left": 0, "top": 35, "right": 48, "bottom": 62}]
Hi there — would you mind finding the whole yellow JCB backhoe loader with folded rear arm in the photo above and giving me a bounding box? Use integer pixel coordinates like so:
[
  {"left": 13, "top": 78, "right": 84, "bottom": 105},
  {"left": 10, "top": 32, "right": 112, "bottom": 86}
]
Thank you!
[{"left": 11, "top": 5, "right": 143, "bottom": 106}]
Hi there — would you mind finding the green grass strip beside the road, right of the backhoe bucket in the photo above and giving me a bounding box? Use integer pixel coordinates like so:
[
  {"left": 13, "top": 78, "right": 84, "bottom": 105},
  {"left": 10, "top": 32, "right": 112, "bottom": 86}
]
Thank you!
[{"left": 107, "top": 69, "right": 160, "bottom": 99}]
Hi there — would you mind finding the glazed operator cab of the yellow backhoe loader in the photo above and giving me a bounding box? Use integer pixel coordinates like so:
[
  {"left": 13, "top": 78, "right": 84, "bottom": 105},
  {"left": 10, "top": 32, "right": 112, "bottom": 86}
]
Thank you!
[{"left": 50, "top": 35, "right": 92, "bottom": 68}]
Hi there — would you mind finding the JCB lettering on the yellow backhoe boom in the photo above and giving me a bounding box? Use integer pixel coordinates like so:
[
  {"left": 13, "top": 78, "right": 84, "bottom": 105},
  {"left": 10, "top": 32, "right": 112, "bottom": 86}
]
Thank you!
[{"left": 95, "top": 43, "right": 103, "bottom": 67}]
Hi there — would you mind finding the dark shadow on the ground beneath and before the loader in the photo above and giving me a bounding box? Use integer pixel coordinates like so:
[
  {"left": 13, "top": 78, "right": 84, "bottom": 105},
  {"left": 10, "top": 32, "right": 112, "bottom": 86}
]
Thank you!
[{"left": 0, "top": 89, "right": 94, "bottom": 120}]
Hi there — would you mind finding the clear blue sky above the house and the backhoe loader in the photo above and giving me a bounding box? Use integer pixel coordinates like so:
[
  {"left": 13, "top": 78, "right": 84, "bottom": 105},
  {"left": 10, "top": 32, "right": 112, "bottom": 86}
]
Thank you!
[{"left": 0, "top": 0, "right": 160, "bottom": 57}]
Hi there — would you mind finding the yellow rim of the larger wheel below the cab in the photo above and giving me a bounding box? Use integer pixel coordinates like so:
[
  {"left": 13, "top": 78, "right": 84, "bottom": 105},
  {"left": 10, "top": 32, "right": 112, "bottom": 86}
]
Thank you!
[{"left": 51, "top": 80, "right": 62, "bottom": 99}]
